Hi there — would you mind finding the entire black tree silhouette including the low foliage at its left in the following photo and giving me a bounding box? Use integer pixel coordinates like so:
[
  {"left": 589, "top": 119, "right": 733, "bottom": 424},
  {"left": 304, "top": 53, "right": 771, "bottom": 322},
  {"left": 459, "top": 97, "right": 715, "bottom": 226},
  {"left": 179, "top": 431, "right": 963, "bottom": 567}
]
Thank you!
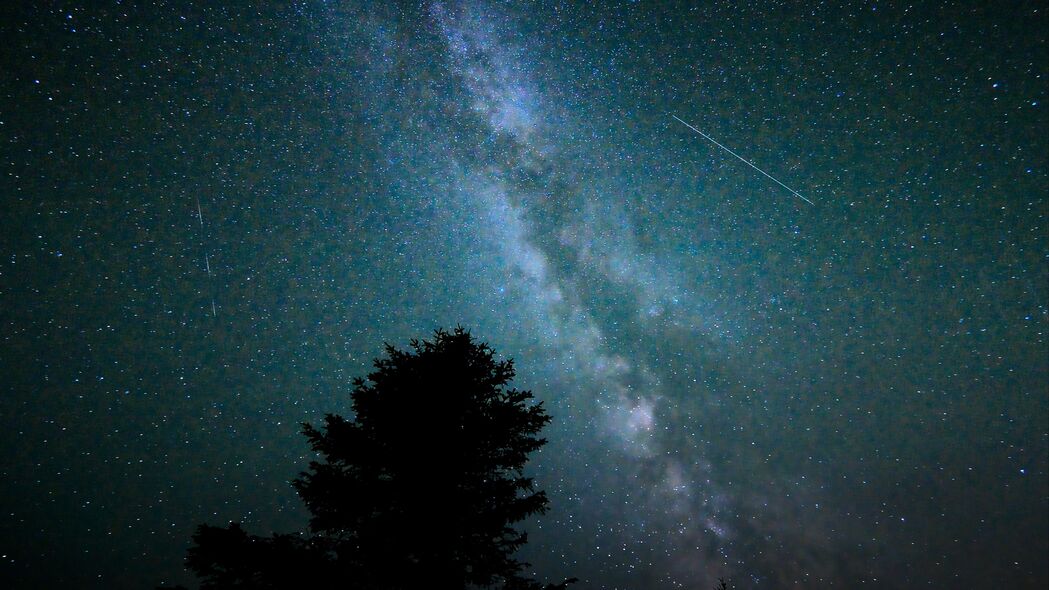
[{"left": 174, "top": 328, "right": 574, "bottom": 590}]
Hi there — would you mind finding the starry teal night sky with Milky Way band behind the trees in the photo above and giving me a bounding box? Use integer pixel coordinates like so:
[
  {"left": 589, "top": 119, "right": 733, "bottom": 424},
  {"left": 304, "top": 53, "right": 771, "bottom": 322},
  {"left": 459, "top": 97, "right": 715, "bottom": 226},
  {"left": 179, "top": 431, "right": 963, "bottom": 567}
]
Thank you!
[{"left": 0, "top": 0, "right": 1049, "bottom": 590}]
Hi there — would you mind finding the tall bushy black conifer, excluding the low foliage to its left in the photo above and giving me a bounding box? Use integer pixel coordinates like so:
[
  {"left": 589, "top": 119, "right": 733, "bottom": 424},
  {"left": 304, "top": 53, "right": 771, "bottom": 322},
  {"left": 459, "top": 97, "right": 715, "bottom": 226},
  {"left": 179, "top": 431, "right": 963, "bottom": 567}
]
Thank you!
[{"left": 295, "top": 329, "right": 550, "bottom": 586}]
